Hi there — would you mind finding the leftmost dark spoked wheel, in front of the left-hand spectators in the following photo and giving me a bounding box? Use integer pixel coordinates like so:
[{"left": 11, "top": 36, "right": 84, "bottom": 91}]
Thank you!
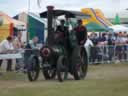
[{"left": 27, "top": 57, "right": 40, "bottom": 81}]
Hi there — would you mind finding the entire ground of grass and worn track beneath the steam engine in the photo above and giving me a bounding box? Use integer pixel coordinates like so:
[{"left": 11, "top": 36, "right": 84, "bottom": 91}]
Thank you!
[{"left": 0, "top": 64, "right": 128, "bottom": 96}]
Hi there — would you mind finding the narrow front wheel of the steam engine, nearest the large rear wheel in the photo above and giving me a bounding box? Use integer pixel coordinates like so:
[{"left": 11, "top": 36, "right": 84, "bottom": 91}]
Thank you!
[{"left": 57, "top": 56, "right": 68, "bottom": 82}]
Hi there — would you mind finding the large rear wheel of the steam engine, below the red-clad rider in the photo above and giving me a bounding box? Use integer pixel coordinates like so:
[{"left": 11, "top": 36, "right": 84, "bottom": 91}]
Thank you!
[{"left": 72, "top": 47, "right": 88, "bottom": 80}]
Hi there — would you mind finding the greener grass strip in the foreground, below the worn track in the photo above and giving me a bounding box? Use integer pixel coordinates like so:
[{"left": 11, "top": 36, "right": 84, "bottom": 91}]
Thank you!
[{"left": 0, "top": 80, "right": 128, "bottom": 96}]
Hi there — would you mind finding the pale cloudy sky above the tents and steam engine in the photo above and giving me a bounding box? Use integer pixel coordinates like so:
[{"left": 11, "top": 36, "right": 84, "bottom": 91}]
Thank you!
[{"left": 0, "top": 0, "right": 128, "bottom": 17}]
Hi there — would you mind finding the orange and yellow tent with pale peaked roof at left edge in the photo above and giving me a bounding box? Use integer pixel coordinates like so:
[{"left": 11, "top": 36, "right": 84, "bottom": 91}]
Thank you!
[{"left": 0, "top": 12, "right": 26, "bottom": 41}]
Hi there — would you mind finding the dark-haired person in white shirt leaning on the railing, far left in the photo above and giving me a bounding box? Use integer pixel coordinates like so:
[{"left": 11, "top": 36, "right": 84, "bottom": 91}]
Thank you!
[{"left": 0, "top": 36, "right": 14, "bottom": 71}]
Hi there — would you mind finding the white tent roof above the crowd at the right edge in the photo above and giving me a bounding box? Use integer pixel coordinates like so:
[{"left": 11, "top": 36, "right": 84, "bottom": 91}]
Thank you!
[{"left": 109, "top": 25, "right": 128, "bottom": 32}]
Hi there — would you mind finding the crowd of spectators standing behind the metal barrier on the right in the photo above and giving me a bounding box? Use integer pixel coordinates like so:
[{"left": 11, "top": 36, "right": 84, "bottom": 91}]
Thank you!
[{"left": 87, "top": 32, "right": 128, "bottom": 63}]
